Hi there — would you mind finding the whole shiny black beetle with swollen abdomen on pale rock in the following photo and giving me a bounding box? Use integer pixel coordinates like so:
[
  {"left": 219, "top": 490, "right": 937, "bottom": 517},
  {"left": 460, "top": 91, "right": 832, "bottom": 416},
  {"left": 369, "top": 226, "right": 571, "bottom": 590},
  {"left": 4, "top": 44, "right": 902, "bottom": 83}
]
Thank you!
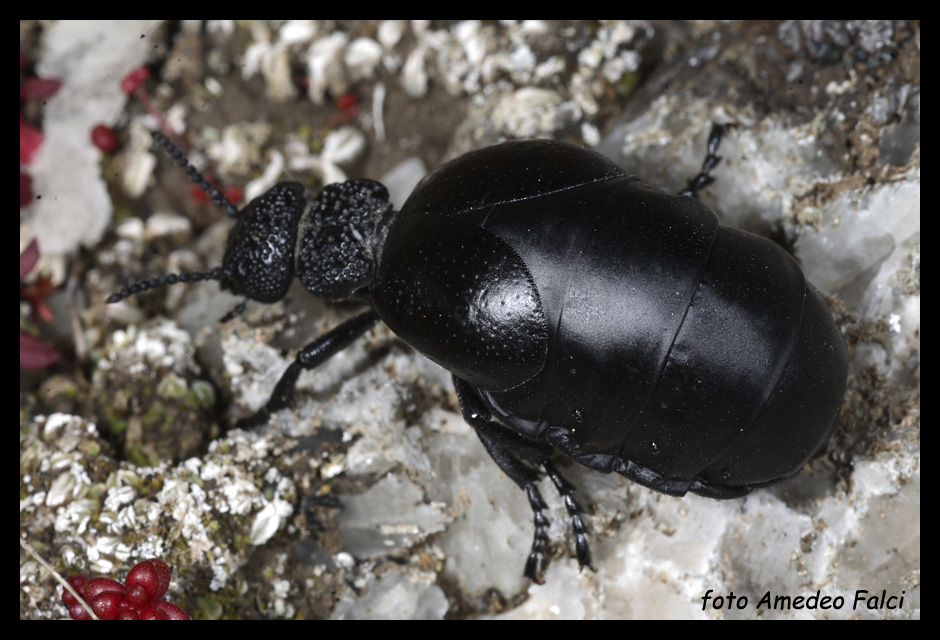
[{"left": 108, "top": 126, "right": 848, "bottom": 580}]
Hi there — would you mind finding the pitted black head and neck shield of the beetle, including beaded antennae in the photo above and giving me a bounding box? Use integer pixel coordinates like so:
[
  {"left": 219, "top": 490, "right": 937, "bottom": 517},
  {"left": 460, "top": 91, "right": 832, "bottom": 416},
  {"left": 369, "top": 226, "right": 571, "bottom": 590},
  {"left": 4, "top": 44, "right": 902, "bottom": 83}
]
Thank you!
[{"left": 108, "top": 132, "right": 391, "bottom": 322}]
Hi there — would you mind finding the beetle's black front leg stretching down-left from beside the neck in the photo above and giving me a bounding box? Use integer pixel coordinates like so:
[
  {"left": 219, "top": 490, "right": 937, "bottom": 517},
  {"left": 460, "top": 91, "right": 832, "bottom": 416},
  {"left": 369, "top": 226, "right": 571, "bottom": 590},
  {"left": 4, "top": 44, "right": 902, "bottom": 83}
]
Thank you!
[{"left": 235, "top": 309, "right": 379, "bottom": 429}]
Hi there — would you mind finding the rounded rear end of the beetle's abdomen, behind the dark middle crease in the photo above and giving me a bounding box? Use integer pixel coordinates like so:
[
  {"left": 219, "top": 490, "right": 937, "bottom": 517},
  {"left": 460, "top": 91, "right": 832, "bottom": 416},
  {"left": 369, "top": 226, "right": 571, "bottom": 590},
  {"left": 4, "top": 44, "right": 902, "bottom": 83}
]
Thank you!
[{"left": 619, "top": 227, "right": 847, "bottom": 486}]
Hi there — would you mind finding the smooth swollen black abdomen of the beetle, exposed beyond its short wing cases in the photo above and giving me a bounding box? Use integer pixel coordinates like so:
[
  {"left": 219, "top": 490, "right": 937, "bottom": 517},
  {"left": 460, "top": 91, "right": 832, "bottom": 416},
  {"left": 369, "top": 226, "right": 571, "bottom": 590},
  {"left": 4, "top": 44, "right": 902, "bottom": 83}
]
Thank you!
[{"left": 478, "top": 177, "right": 847, "bottom": 497}]
